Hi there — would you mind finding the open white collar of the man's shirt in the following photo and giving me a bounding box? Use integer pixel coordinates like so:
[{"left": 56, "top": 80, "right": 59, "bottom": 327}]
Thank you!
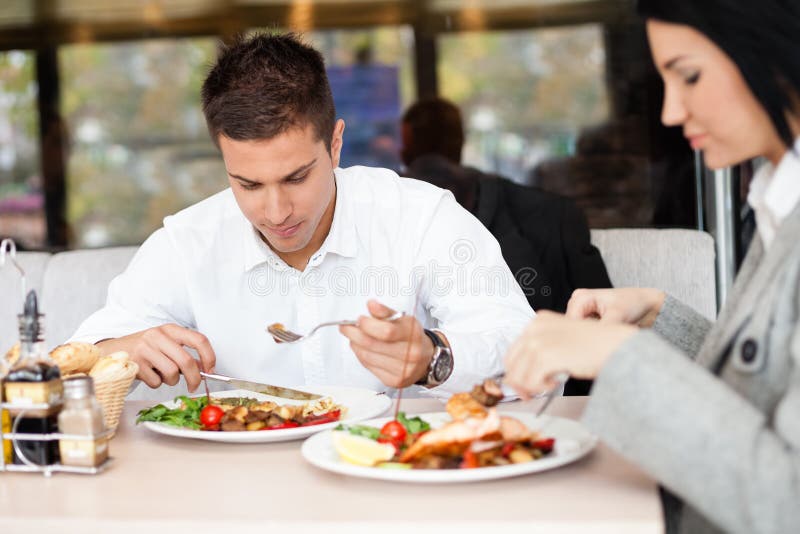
[{"left": 242, "top": 169, "right": 358, "bottom": 272}]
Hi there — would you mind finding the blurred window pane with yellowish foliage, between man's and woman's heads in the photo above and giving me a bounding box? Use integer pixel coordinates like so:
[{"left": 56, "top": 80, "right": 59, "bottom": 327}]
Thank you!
[{"left": 438, "top": 24, "right": 609, "bottom": 187}]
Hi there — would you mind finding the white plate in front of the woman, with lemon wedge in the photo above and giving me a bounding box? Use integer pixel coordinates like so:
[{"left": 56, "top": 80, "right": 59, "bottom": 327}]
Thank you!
[{"left": 302, "top": 412, "right": 597, "bottom": 484}]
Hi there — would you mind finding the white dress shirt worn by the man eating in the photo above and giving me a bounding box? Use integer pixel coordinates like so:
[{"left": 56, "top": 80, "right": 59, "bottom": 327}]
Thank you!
[{"left": 73, "top": 167, "right": 534, "bottom": 394}]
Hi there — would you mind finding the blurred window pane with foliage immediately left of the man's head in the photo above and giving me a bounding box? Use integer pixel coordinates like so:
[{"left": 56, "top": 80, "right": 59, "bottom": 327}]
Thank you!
[{"left": 59, "top": 38, "right": 227, "bottom": 248}]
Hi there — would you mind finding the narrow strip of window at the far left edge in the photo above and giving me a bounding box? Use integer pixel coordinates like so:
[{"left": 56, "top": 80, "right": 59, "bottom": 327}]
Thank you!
[{"left": 0, "top": 50, "right": 47, "bottom": 248}]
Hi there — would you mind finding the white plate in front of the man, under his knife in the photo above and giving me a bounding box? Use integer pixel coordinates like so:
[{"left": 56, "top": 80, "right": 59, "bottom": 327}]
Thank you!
[{"left": 142, "top": 386, "right": 392, "bottom": 443}]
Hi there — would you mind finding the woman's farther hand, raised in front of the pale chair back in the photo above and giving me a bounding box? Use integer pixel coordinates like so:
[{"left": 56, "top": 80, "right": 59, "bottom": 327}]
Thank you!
[{"left": 567, "top": 287, "right": 667, "bottom": 328}]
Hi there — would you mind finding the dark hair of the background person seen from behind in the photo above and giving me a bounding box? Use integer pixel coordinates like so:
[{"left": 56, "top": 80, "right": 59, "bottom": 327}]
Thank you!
[{"left": 402, "top": 98, "right": 464, "bottom": 165}]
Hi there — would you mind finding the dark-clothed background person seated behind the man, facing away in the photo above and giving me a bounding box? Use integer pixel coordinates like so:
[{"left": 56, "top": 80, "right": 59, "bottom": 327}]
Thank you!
[{"left": 400, "top": 98, "right": 611, "bottom": 395}]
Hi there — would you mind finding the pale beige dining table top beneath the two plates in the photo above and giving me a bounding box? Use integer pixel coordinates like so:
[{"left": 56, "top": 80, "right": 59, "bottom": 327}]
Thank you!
[{"left": 0, "top": 397, "right": 664, "bottom": 534}]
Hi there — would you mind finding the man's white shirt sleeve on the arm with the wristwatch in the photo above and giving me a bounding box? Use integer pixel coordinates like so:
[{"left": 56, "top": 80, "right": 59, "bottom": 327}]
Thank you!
[{"left": 417, "top": 192, "right": 534, "bottom": 396}]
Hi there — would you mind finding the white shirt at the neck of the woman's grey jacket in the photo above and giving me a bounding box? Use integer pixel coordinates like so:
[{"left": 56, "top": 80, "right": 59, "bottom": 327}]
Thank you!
[{"left": 747, "top": 138, "right": 800, "bottom": 250}]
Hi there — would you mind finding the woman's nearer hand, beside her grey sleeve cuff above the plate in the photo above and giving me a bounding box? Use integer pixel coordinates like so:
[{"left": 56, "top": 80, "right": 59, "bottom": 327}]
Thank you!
[{"left": 504, "top": 311, "right": 638, "bottom": 398}]
